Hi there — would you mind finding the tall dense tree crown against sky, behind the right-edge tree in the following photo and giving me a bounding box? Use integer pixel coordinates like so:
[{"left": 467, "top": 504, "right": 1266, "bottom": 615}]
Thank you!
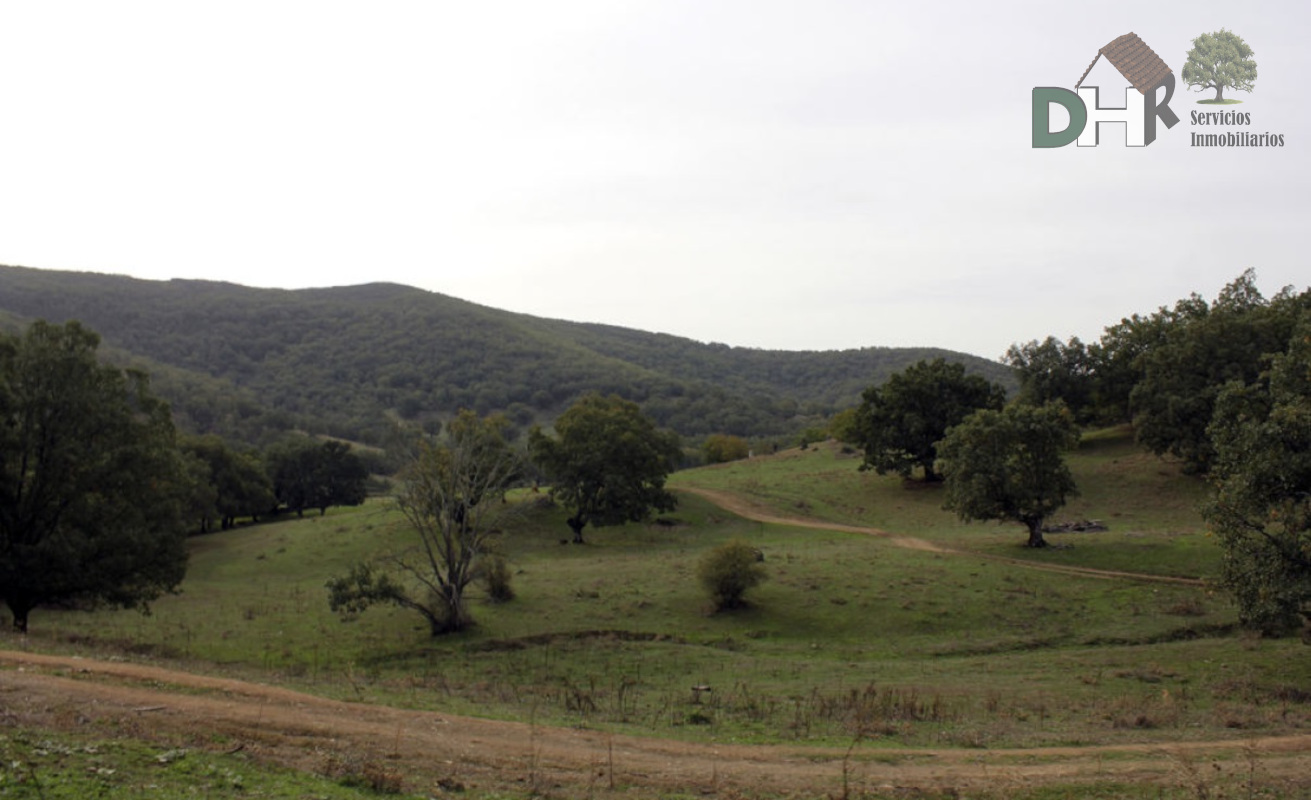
[{"left": 1130, "top": 270, "right": 1311, "bottom": 472}]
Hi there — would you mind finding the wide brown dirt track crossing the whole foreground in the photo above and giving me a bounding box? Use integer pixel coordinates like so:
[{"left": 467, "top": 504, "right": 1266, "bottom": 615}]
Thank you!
[{"left": 0, "top": 650, "right": 1311, "bottom": 797}]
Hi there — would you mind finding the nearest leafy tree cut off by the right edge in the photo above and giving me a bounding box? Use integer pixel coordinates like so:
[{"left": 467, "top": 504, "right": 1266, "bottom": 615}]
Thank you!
[{"left": 1205, "top": 312, "right": 1311, "bottom": 632}]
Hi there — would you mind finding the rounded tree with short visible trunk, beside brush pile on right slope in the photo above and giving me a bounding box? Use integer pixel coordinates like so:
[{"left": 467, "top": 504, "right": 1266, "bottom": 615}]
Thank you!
[{"left": 939, "top": 403, "right": 1079, "bottom": 547}]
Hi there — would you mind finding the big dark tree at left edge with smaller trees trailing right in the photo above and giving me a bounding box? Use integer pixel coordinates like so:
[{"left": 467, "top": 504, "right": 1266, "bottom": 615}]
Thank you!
[{"left": 0, "top": 321, "right": 367, "bottom": 631}]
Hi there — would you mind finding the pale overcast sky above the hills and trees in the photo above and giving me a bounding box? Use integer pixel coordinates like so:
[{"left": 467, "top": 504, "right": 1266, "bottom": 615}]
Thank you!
[{"left": 0, "top": 0, "right": 1311, "bottom": 358}]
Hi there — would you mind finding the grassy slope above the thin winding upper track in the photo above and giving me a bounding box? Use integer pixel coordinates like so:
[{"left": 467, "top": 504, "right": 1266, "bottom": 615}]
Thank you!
[{"left": 670, "top": 429, "right": 1219, "bottom": 578}]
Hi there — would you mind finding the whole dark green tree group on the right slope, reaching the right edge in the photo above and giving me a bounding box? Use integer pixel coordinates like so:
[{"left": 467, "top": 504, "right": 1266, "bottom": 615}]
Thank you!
[{"left": 834, "top": 270, "right": 1311, "bottom": 632}]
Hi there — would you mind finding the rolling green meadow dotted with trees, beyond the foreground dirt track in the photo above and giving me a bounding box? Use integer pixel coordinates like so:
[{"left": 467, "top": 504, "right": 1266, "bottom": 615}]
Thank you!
[{"left": 0, "top": 431, "right": 1311, "bottom": 796}]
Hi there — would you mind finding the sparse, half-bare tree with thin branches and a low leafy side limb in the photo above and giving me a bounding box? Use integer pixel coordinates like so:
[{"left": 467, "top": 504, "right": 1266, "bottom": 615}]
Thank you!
[{"left": 328, "top": 410, "right": 522, "bottom": 636}]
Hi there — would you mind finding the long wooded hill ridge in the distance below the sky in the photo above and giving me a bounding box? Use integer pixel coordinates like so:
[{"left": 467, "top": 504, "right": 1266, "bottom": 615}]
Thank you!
[{"left": 0, "top": 266, "right": 1013, "bottom": 443}]
